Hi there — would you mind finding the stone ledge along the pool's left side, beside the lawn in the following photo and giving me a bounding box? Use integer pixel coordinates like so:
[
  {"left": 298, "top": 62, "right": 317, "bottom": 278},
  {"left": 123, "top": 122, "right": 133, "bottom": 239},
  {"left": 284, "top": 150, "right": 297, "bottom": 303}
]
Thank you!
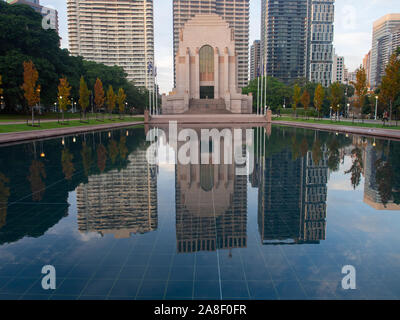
[{"left": 0, "top": 121, "right": 143, "bottom": 145}]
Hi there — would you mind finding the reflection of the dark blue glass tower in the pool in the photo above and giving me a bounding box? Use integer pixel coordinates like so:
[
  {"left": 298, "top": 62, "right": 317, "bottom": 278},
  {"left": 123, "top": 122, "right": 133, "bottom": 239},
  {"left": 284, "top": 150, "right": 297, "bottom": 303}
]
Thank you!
[{"left": 258, "top": 147, "right": 328, "bottom": 244}]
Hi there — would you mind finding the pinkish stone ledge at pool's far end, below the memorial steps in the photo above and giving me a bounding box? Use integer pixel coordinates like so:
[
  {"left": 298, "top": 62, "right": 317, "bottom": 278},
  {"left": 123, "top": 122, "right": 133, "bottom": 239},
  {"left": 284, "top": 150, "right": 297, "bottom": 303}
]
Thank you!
[{"left": 150, "top": 114, "right": 267, "bottom": 125}]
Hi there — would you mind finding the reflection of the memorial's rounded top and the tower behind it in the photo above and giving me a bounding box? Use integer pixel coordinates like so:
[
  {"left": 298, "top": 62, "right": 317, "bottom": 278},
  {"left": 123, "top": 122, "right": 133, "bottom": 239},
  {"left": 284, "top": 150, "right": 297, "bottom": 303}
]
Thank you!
[{"left": 175, "top": 126, "right": 247, "bottom": 253}]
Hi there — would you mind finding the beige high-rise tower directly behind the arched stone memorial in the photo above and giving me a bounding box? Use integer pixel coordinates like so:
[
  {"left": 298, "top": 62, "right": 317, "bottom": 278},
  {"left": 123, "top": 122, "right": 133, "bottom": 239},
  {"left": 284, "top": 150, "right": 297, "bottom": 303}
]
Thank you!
[{"left": 173, "top": 0, "right": 250, "bottom": 88}]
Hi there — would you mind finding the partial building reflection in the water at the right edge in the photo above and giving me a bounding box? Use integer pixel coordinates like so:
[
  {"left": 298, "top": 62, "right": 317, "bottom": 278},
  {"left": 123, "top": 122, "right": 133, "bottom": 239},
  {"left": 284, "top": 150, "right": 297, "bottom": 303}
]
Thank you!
[{"left": 364, "top": 144, "right": 400, "bottom": 210}]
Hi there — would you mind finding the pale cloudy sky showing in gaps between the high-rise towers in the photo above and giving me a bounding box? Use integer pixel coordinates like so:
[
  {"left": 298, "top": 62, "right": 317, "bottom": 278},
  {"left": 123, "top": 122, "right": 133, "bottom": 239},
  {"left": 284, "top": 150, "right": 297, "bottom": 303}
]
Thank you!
[{"left": 40, "top": 0, "right": 400, "bottom": 93}]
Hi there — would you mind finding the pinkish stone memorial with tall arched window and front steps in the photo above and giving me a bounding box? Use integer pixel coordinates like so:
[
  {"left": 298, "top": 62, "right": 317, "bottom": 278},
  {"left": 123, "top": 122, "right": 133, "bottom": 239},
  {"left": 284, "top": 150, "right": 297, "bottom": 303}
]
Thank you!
[{"left": 162, "top": 14, "right": 253, "bottom": 114}]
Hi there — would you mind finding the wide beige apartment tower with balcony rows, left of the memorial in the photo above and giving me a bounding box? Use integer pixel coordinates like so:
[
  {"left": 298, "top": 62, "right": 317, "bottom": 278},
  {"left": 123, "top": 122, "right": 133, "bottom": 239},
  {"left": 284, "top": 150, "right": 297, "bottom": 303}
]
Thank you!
[{"left": 67, "top": 0, "right": 154, "bottom": 89}]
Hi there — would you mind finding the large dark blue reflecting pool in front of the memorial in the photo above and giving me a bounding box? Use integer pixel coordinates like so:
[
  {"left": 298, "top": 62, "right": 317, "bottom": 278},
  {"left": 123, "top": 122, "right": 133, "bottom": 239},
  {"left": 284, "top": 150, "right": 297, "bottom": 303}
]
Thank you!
[{"left": 0, "top": 126, "right": 400, "bottom": 299}]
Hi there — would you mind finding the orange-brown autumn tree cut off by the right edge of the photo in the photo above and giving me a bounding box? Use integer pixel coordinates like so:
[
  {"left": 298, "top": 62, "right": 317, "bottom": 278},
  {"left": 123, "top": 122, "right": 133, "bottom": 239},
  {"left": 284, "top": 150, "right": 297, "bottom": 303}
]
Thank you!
[{"left": 380, "top": 54, "right": 400, "bottom": 124}]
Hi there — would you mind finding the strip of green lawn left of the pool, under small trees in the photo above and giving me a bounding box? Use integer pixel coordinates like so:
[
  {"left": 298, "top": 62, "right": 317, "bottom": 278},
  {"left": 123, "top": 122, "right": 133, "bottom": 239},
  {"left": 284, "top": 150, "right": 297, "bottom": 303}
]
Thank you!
[{"left": 0, "top": 117, "right": 144, "bottom": 133}]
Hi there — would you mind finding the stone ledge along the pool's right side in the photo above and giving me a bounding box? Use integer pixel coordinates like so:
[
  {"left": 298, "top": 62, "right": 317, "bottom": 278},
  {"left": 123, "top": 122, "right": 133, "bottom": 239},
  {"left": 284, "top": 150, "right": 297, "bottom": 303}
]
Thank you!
[{"left": 272, "top": 120, "right": 400, "bottom": 140}]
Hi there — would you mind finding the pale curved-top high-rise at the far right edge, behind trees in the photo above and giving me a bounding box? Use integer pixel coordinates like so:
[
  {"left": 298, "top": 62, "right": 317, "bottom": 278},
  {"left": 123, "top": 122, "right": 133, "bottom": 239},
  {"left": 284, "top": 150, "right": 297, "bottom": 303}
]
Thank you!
[{"left": 370, "top": 13, "right": 400, "bottom": 88}]
